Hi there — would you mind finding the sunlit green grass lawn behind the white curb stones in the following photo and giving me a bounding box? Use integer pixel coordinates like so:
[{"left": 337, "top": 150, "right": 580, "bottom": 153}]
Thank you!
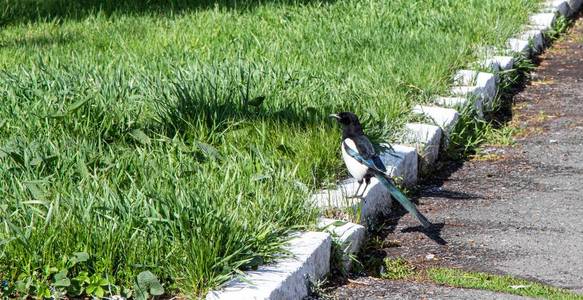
[{"left": 0, "top": 0, "right": 539, "bottom": 296}]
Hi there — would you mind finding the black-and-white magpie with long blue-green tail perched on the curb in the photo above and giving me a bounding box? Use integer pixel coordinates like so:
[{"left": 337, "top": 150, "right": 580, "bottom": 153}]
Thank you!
[{"left": 329, "top": 112, "right": 433, "bottom": 228}]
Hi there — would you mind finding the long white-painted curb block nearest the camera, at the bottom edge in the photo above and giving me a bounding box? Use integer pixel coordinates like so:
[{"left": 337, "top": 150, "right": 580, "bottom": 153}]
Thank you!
[{"left": 206, "top": 232, "right": 332, "bottom": 300}]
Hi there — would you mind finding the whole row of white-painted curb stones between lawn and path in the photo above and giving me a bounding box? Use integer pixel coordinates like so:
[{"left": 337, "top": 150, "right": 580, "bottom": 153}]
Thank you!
[{"left": 206, "top": 0, "right": 583, "bottom": 300}]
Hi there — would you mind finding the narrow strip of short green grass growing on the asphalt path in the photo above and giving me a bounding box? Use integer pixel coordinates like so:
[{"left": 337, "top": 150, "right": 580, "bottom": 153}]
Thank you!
[{"left": 427, "top": 268, "right": 583, "bottom": 299}]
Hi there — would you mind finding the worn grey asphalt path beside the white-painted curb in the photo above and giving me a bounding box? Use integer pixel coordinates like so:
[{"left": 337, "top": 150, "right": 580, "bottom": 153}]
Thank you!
[{"left": 334, "top": 19, "right": 583, "bottom": 299}]
